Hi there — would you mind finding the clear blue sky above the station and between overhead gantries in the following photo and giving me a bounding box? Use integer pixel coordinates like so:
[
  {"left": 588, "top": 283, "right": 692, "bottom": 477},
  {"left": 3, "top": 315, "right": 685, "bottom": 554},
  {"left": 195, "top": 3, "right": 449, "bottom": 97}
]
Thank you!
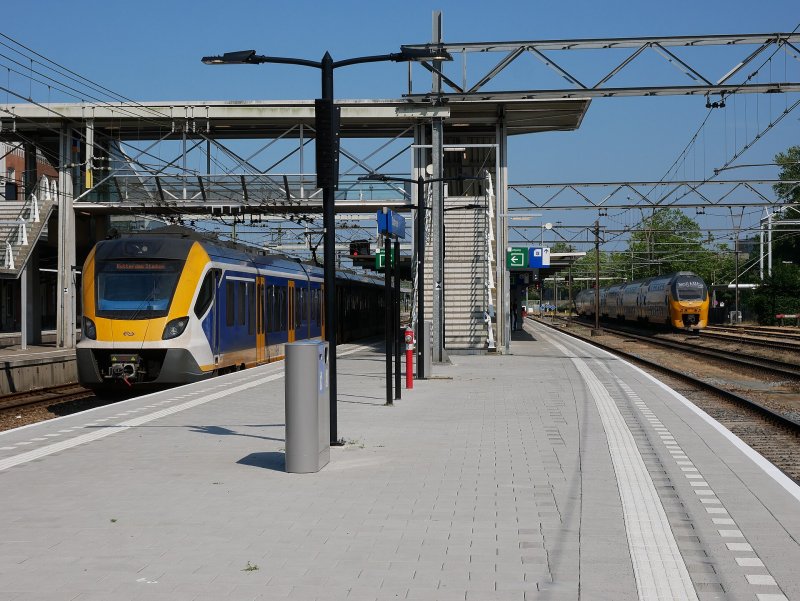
[{"left": 0, "top": 0, "right": 800, "bottom": 251}]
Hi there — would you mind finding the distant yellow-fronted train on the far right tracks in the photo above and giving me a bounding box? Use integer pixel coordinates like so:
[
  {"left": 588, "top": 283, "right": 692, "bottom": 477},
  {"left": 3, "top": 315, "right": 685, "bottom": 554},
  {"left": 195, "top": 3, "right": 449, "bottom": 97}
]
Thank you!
[{"left": 575, "top": 271, "right": 709, "bottom": 329}]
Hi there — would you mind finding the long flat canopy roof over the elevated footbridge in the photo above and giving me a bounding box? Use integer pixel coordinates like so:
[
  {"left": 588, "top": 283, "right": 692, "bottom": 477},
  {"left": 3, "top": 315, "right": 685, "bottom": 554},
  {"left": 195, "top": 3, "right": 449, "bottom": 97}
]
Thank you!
[{"left": 0, "top": 98, "right": 590, "bottom": 141}]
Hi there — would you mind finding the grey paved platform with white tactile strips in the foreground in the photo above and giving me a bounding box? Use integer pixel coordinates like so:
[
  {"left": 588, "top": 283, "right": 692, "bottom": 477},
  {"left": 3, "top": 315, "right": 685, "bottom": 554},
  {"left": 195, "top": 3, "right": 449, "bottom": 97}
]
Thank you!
[{"left": 0, "top": 324, "right": 800, "bottom": 601}]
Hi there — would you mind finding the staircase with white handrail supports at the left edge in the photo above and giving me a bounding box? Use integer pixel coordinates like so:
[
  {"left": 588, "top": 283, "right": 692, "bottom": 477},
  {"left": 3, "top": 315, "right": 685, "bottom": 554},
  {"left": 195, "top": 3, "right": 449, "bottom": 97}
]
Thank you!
[{"left": 0, "top": 177, "right": 57, "bottom": 278}]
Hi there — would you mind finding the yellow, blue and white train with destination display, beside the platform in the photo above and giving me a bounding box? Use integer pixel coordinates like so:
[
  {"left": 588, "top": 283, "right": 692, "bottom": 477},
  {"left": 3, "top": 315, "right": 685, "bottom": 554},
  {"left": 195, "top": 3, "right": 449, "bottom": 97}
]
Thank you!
[{"left": 77, "top": 234, "right": 384, "bottom": 389}]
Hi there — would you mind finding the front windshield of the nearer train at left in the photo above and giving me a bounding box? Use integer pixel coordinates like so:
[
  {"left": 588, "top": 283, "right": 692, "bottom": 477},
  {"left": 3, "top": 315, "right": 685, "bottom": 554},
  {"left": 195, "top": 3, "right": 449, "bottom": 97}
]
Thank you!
[{"left": 95, "top": 261, "right": 183, "bottom": 319}]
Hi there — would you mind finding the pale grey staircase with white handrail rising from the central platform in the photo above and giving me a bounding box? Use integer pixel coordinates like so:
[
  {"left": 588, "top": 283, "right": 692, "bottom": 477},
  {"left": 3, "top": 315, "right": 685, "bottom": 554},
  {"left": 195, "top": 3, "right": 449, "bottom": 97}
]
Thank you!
[{"left": 425, "top": 182, "right": 494, "bottom": 354}]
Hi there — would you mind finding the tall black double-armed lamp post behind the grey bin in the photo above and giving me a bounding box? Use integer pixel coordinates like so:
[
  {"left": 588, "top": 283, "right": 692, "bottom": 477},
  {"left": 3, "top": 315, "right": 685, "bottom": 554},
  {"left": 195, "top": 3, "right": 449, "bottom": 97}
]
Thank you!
[{"left": 202, "top": 45, "right": 453, "bottom": 445}]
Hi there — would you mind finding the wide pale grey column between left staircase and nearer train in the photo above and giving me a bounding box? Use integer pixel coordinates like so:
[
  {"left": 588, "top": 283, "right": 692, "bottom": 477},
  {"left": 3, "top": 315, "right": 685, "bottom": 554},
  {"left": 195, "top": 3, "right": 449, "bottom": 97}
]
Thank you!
[{"left": 56, "top": 125, "right": 75, "bottom": 348}]
